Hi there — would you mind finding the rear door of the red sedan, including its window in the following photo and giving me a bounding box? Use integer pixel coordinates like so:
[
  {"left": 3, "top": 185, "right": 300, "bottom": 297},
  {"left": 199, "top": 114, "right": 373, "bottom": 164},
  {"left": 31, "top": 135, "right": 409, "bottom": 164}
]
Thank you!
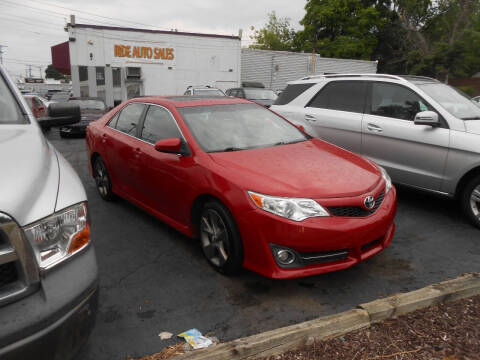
[{"left": 102, "top": 103, "right": 147, "bottom": 197}]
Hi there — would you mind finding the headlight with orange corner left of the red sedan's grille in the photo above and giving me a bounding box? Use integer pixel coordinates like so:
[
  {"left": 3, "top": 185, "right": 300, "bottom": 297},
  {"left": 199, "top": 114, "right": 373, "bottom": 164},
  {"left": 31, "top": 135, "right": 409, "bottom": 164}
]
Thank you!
[{"left": 248, "top": 191, "right": 330, "bottom": 221}]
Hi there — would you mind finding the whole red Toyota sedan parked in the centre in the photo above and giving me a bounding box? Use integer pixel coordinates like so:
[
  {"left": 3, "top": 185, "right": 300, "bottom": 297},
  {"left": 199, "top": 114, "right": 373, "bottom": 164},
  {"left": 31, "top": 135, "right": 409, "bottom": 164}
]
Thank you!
[{"left": 87, "top": 96, "right": 396, "bottom": 278}]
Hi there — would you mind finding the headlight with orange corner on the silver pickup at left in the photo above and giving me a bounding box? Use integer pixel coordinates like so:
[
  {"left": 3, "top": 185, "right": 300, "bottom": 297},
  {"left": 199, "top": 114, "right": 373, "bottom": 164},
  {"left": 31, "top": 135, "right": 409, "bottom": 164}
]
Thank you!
[{"left": 23, "top": 202, "right": 90, "bottom": 270}]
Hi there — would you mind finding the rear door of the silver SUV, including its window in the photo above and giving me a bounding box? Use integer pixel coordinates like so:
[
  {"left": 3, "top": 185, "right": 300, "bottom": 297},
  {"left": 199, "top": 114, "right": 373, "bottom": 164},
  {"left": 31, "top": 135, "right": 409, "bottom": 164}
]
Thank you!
[{"left": 304, "top": 81, "right": 367, "bottom": 153}]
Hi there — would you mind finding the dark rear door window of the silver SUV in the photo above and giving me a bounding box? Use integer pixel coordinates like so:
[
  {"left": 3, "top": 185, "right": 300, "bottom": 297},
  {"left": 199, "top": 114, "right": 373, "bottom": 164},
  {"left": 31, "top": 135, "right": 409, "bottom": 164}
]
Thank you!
[{"left": 308, "top": 81, "right": 367, "bottom": 113}]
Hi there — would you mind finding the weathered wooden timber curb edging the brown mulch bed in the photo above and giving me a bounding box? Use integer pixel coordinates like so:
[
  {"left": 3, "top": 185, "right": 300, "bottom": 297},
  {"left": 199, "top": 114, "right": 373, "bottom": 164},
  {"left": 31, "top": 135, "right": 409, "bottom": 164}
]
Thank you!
[{"left": 174, "top": 273, "right": 480, "bottom": 360}]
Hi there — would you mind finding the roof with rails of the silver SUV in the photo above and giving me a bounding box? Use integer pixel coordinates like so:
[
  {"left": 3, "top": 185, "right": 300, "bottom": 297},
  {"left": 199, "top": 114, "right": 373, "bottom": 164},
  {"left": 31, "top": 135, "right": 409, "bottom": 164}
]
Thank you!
[{"left": 288, "top": 73, "right": 440, "bottom": 85}]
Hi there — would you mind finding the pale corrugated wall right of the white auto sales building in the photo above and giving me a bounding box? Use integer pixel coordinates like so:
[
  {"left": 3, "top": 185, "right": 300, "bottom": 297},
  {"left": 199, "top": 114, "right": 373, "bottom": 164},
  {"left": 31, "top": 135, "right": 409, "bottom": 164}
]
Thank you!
[{"left": 241, "top": 49, "right": 377, "bottom": 90}]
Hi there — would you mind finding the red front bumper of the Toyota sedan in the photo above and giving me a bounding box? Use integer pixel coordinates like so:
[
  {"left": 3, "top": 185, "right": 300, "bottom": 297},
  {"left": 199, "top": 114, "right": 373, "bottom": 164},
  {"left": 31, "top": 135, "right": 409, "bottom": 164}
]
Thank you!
[{"left": 237, "top": 187, "right": 397, "bottom": 279}]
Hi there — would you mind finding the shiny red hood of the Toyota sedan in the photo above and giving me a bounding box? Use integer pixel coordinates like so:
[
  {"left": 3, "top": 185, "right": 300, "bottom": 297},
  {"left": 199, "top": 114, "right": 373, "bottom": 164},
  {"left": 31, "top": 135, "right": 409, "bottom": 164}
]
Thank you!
[{"left": 209, "top": 139, "right": 381, "bottom": 199}]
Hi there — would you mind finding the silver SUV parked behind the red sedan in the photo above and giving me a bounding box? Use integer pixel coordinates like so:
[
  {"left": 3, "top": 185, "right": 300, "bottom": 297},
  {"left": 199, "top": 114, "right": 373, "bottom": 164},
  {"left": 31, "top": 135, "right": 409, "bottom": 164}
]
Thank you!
[{"left": 272, "top": 74, "right": 480, "bottom": 227}]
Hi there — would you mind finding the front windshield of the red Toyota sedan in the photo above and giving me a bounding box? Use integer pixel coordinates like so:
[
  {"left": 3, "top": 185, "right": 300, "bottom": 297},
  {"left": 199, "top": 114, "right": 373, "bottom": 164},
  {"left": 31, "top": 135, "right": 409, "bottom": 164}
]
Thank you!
[{"left": 179, "top": 104, "right": 307, "bottom": 152}]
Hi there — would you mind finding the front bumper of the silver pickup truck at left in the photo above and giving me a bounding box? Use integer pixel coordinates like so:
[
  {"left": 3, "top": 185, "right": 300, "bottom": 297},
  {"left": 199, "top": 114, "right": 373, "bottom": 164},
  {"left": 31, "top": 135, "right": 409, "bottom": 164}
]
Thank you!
[{"left": 0, "top": 245, "right": 98, "bottom": 360}]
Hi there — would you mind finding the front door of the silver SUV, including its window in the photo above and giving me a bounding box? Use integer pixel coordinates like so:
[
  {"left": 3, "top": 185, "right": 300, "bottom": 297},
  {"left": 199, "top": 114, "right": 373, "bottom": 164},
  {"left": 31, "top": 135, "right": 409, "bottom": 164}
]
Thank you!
[{"left": 362, "top": 82, "right": 450, "bottom": 190}]
